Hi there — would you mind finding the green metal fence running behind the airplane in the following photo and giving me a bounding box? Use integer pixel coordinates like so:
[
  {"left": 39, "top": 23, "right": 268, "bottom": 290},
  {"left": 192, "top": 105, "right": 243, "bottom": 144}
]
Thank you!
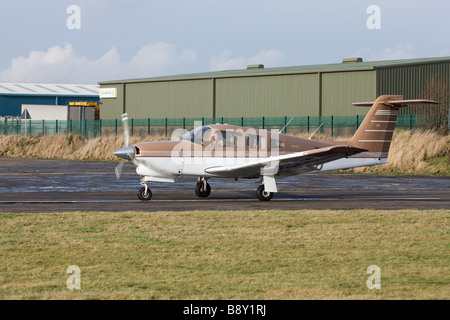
[{"left": 0, "top": 115, "right": 422, "bottom": 138}]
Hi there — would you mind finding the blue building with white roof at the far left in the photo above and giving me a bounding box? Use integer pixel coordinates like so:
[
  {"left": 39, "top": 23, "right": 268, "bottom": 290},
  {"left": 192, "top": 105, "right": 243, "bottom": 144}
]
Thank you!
[{"left": 0, "top": 82, "right": 100, "bottom": 120}]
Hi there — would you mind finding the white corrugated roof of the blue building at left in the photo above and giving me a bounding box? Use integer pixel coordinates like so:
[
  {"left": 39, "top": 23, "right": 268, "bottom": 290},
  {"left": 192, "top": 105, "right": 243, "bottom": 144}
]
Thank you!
[{"left": 0, "top": 82, "right": 100, "bottom": 96}]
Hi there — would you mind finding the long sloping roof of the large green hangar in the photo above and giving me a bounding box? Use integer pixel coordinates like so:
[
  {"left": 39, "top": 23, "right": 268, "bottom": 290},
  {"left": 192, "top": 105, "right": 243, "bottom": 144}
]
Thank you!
[{"left": 99, "top": 57, "right": 450, "bottom": 85}]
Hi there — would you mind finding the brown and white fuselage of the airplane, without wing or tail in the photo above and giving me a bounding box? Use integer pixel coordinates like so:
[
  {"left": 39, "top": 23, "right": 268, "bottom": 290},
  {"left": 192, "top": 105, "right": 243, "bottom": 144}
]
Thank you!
[{"left": 124, "top": 124, "right": 381, "bottom": 182}]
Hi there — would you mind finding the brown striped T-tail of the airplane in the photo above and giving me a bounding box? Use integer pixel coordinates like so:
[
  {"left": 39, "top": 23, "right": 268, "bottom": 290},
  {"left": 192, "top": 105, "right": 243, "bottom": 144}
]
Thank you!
[{"left": 349, "top": 95, "right": 438, "bottom": 160}]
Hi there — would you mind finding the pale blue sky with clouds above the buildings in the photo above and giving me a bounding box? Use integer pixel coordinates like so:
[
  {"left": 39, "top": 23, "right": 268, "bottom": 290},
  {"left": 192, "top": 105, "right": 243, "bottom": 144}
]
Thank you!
[{"left": 0, "top": 0, "right": 450, "bottom": 84}]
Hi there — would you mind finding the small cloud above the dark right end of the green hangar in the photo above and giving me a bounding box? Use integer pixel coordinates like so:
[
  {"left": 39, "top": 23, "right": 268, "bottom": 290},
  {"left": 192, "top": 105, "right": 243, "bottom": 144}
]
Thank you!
[{"left": 354, "top": 43, "right": 416, "bottom": 61}]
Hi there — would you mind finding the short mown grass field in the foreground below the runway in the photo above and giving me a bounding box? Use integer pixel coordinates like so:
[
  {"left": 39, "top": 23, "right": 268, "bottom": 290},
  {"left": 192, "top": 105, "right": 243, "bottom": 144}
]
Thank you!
[{"left": 0, "top": 210, "right": 450, "bottom": 300}]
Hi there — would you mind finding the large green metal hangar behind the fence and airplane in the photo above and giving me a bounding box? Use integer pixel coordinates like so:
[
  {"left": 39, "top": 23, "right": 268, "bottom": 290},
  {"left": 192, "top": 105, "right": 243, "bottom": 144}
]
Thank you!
[{"left": 99, "top": 57, "right": 450, "bottom": 119}]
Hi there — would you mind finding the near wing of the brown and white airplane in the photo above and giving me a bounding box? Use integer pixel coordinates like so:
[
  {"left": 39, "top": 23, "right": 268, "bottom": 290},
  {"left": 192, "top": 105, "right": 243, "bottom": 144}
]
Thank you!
[{"left": 205, "top": 145, "right": 367, "bottom": 178}]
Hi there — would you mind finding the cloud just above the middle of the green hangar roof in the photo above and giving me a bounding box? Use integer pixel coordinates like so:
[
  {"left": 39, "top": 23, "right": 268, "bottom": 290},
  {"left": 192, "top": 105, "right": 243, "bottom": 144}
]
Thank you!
[{"left": 209, "top": 49, "right": 284, "bottom": 71}]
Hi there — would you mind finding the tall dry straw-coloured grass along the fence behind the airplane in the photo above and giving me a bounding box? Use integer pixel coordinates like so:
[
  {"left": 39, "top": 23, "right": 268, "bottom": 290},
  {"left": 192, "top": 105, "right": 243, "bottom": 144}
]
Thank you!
[{"left": 0, "top": 131, "right": 450, "bottom": 175}]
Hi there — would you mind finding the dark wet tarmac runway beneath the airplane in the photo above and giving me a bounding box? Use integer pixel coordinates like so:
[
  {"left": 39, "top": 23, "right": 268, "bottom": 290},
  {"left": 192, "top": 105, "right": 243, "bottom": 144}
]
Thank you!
[{"left": 0, "top": 158, "right": 450, "bottom": 213}]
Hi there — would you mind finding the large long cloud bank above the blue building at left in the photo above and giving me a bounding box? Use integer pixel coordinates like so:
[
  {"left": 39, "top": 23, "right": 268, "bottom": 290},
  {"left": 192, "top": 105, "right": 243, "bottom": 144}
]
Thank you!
[{"left": 0, "top": 42, "right": 197, "bottom": 83}]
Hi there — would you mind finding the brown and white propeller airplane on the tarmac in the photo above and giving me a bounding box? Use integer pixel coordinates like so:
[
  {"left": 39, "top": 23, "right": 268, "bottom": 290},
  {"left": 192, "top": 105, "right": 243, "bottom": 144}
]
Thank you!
[{"left": 114, "top": 95, "right": 438, "bottom": 201}]
